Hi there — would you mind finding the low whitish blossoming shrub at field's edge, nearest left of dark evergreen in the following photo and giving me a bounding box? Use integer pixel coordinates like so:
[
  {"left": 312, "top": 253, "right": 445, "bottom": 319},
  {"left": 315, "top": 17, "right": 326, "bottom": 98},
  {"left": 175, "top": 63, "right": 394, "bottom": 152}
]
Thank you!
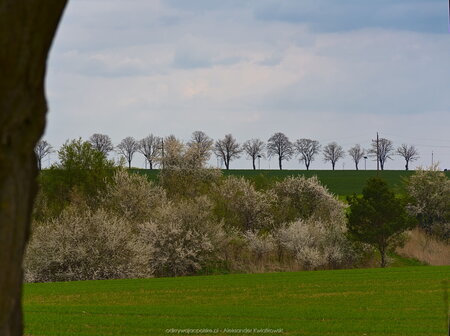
[{"left": 275, "top": 219, "right": 353, "bottom": 269}]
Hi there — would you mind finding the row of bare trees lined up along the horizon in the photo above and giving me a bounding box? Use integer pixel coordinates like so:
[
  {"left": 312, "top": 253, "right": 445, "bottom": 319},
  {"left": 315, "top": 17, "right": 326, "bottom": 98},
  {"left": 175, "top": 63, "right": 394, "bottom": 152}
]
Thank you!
[{"left": 35, "top": 131, "right": 419, "bottom": 170}]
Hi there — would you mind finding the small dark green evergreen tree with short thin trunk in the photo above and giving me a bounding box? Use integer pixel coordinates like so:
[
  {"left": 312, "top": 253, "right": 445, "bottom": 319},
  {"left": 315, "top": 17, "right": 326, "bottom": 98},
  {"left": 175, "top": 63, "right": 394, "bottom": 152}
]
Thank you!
[{"left": 347, "top": 177, "right": 414, "bottom": 267}]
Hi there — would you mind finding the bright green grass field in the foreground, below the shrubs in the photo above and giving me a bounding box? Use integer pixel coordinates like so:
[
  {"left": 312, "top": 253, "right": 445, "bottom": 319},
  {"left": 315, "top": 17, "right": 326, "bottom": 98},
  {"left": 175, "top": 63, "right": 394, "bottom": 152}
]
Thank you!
[{"left": 24, "top": 266, "right": 450, "bottom": 336}]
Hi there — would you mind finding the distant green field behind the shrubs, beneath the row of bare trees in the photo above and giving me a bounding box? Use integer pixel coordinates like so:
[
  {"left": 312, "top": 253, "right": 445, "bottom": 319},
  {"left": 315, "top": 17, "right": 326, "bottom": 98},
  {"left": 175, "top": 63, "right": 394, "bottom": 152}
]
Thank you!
[{"left": 134, "top": 169, "right": 450, "bottom": 196}]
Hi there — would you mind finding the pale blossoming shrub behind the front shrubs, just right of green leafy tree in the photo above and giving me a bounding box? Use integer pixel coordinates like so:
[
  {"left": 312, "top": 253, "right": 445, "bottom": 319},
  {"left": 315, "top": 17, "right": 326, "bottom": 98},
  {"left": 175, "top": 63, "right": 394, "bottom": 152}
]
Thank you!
[{"left": 102, "top": 169, "right": 167, "bottom": 222}]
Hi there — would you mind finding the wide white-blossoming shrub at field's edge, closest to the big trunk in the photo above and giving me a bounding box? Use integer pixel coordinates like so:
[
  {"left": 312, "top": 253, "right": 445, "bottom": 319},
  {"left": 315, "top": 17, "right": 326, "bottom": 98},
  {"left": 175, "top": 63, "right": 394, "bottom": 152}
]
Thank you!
[{"left": 25, "top": 207, "right": 143, "bottom": 282}]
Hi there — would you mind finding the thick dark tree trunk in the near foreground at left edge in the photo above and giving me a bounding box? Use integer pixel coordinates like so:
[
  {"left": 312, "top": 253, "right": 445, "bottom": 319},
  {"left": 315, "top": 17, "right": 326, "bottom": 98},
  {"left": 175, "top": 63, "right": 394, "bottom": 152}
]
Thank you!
[{"left": 0, "top": 0, "right": 66, "bottom": 336}]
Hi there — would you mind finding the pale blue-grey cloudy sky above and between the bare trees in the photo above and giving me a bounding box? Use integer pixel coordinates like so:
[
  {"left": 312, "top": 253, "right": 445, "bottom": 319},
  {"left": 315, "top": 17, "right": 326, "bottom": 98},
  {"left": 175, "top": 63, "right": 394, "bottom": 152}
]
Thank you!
[{"left": 45, "top": 0, "right": 450, "bottom": 169}]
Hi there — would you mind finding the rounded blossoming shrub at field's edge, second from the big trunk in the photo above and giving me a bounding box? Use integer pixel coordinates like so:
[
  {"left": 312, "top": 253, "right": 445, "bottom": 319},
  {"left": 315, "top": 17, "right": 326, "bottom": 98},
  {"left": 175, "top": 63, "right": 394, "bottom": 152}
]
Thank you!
[{"left": 139, "top": 197, "right": 224, "bottom": 276}]
